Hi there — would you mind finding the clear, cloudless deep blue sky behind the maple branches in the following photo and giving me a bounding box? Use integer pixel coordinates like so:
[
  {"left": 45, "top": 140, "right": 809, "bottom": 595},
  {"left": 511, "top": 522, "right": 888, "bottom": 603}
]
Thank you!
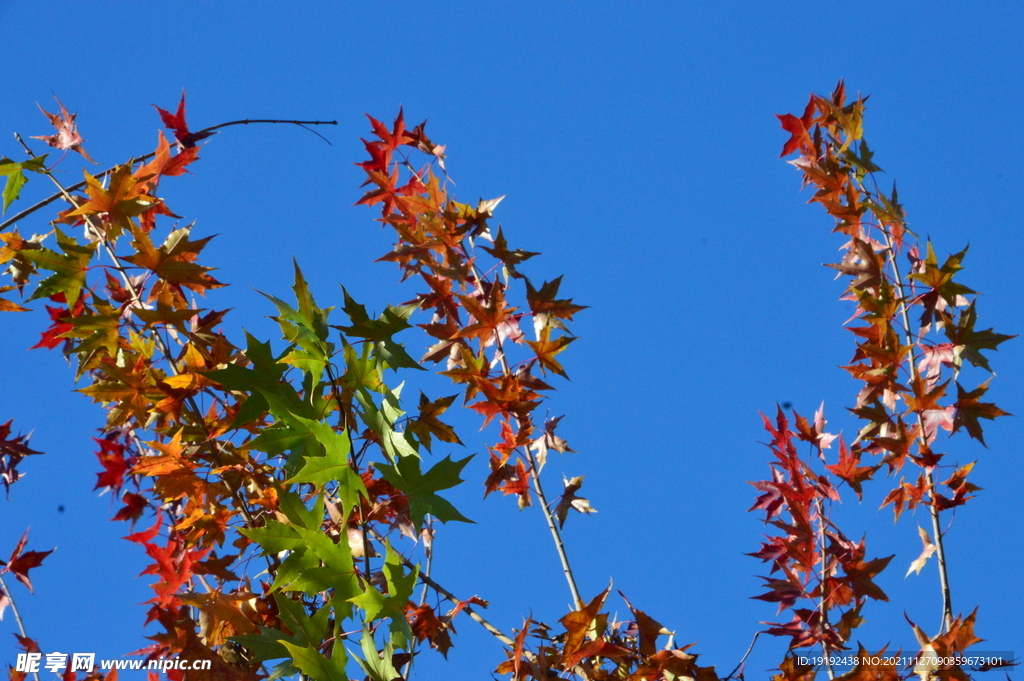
[{"left": 0, "top": 2, "right": 1024, "bottom": 679}]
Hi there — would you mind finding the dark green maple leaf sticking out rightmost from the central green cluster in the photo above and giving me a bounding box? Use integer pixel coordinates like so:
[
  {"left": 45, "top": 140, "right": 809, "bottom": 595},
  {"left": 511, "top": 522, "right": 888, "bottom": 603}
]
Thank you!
[{"left": 377, "top": 455, "right": 473, "bottom": 529}]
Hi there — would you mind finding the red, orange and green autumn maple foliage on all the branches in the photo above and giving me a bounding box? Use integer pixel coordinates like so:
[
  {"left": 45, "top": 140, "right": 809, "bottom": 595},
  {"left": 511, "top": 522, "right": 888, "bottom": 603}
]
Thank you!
[{"left": 0, "top": 83, "right": 1010, "bottom": 681}]
